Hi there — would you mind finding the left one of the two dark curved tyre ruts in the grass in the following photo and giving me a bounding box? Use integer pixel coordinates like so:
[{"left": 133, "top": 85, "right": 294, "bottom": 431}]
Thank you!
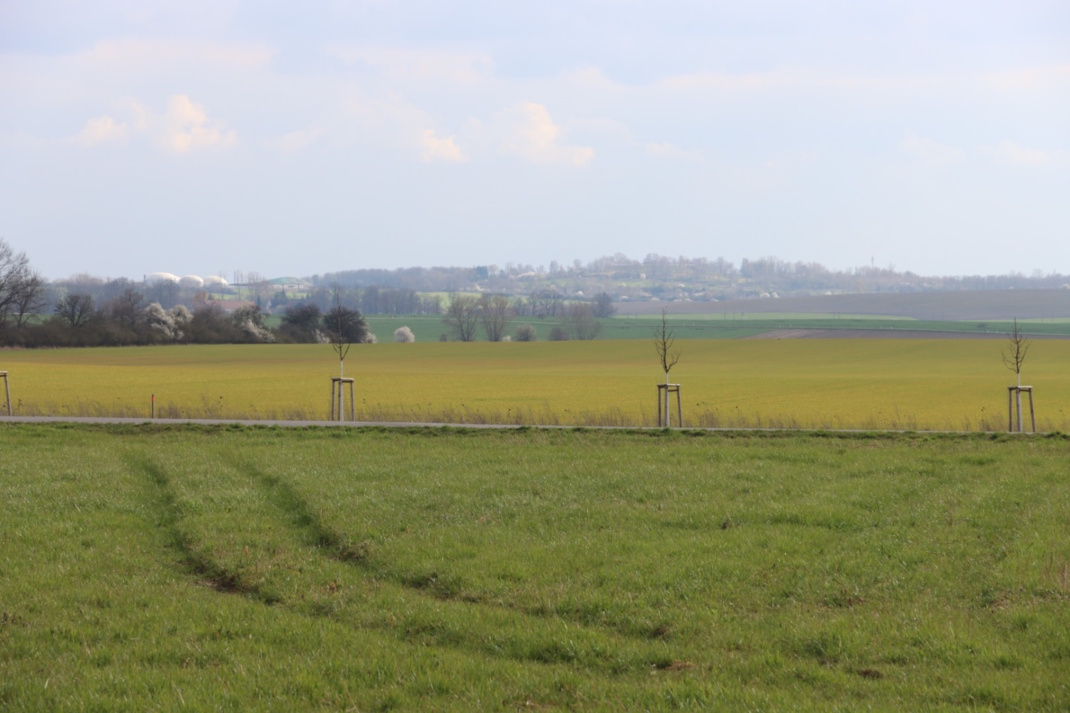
[{"left": 127, "top": 449, "right": 276, "bottom": 604}]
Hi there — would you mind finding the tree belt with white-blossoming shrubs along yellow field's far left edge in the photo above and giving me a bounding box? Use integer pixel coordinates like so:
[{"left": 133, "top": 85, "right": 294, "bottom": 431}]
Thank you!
[{"left": 0, "top": 239, "right": 615, "bottom": 347}]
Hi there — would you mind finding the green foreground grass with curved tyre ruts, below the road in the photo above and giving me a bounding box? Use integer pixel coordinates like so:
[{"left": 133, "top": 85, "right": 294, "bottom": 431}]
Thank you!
[{"left": 0, "top": 424, "right": 1070, "bottom": 711}]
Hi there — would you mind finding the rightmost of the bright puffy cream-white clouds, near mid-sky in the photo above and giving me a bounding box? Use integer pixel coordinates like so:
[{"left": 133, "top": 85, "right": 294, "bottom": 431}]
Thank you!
[{"left": 491, "top": 102, "right": 595, "bottom": 166}]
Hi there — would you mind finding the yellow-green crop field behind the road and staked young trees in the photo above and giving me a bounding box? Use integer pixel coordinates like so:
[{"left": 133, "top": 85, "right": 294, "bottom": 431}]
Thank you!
[{"left": 0, "top": 339, "right": 1070, "bottom": 431}]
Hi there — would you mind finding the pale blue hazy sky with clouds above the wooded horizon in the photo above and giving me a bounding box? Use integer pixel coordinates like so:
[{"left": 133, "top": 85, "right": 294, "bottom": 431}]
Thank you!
[{"left": 0, "top": 0, "right": 1070, "bottom": 279}]
